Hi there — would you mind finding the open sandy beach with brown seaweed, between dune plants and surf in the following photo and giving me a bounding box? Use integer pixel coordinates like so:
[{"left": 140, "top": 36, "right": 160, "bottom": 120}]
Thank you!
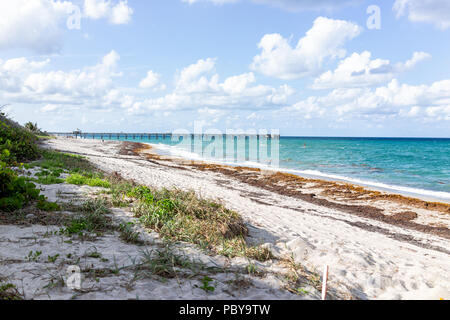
[{"left": 38, "top": 139, "right": 450, "bottom": 299}]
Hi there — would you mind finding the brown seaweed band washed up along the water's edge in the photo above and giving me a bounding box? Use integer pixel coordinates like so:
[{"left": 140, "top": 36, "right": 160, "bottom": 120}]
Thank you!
[{"left": 130, "top": 142, "right": 450, "bottom": 245}]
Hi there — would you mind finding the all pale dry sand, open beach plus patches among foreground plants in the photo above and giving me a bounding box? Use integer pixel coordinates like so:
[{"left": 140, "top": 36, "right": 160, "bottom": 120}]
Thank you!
[{"left": 0, "top": 138, "right": 450, "bottom": 299}]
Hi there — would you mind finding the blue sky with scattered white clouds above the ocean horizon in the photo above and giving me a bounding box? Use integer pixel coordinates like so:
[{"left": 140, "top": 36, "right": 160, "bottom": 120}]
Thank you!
[{"left": 0, "top": 0, "right": 450, "bottom": 137}]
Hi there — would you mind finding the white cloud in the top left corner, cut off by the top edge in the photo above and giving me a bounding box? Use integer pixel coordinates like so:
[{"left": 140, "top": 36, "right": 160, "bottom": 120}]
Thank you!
[{"left": 0, "top": 0, "right": 133, "bottom": 54}]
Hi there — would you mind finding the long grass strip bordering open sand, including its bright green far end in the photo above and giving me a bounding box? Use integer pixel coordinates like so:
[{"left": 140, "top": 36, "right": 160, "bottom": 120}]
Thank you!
[{"left": 61, "top": 168, "right": 273, "bottom": 261}]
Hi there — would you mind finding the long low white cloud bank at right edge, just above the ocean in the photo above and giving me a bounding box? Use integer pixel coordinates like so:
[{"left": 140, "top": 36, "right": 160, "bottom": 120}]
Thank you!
[{"left": 283, "top": 79, "right": 450, "bottom": 121}]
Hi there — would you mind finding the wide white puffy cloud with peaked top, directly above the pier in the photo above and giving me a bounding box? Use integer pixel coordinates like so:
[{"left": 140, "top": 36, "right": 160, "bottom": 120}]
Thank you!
[{"left": 134, "top": 58, "right": 294, "bottom": 112}]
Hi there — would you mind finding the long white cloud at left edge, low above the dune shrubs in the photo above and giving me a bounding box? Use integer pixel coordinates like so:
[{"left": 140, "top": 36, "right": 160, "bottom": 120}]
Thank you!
[{"left": 0, "top": 50, "right": 121, "bottom": 105}]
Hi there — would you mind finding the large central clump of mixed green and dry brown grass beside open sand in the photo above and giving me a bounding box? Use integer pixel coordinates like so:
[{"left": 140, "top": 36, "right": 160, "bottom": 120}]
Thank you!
[{"left": 128, "top": 186, "right": 273, "bottom": 261}]
